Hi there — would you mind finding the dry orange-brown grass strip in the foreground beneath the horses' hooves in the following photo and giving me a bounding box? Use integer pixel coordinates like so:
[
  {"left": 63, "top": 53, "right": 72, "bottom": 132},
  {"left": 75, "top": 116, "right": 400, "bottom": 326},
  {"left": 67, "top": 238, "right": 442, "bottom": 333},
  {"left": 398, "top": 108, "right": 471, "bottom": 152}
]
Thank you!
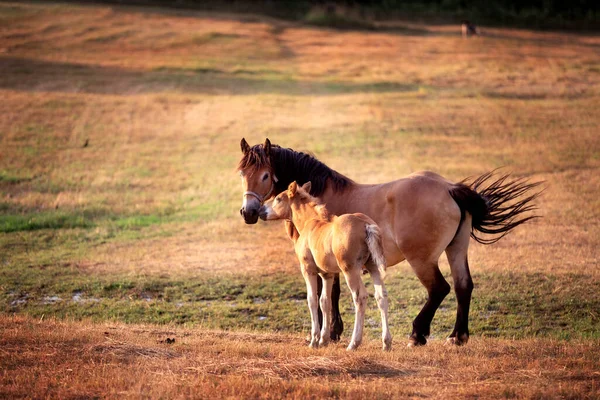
[{"left": 0, "top": 316, "right": 600, "bottom": 398}]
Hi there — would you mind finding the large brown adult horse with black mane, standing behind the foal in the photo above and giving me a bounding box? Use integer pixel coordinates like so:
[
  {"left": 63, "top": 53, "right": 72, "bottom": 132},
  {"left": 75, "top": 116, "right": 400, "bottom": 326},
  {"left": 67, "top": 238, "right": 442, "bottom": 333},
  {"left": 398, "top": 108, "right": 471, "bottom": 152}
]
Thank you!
[{"left": 238, "top": 139, "right": 540, "bottom": 345}]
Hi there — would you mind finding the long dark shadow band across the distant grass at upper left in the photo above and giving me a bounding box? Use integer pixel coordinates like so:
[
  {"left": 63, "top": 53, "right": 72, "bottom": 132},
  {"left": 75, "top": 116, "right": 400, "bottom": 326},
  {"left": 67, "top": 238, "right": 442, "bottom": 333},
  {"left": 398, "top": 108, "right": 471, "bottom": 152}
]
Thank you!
[{"left": 0, "top": 57, "right": 419, "bottom": 96}]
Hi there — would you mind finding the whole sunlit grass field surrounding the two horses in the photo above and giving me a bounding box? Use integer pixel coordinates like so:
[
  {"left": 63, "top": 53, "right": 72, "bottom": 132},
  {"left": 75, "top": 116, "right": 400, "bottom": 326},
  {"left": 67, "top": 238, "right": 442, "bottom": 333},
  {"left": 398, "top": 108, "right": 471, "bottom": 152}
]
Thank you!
[{"left": 0, "top": 2, "right": 600, "bottom": 398}]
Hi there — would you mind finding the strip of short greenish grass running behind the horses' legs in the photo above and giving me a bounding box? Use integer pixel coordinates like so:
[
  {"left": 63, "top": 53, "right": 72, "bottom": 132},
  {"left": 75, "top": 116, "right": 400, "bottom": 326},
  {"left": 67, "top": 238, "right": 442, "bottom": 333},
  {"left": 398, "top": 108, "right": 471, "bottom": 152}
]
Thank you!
[{"left": 0, "top": 262, "right": 600, "bottom": 340}]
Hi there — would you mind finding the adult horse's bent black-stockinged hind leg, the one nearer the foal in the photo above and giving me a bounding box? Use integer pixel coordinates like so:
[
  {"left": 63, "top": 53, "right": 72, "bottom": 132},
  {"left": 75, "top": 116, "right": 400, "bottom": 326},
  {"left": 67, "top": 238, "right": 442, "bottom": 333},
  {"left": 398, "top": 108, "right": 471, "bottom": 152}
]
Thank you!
[{"left": 408, "top": 260, "right": 450, "bottom": 347}]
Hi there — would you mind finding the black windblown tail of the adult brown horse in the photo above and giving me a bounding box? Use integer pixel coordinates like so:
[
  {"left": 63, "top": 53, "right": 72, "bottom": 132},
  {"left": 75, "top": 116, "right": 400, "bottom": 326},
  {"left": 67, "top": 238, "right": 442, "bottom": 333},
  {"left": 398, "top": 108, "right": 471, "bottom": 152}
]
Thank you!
[{"left": 450, "top": 171, "right": 543, "bottom": 244}]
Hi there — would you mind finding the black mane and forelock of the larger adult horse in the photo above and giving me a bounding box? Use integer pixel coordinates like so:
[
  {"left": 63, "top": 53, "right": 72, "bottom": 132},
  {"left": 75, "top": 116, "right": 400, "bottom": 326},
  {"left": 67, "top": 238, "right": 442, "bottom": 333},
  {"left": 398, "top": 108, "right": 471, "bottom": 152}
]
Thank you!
[{"left": 237, "top": 144, "right": 354, "bottom": 197}]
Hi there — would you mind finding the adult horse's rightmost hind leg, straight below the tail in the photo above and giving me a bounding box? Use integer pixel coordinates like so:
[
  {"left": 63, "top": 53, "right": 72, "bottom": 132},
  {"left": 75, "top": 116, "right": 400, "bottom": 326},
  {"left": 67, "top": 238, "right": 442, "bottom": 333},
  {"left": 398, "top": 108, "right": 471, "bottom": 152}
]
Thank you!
[{"left": 446, "top": 218, "right": 473, "bottom": 345}]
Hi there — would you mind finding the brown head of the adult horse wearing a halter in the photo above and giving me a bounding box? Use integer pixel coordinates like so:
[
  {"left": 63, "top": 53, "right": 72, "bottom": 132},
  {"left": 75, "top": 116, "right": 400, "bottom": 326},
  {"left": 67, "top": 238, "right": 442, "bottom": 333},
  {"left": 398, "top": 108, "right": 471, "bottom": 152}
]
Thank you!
[{"left": 237, "top": 139, "right": 277, "bottom": 224}]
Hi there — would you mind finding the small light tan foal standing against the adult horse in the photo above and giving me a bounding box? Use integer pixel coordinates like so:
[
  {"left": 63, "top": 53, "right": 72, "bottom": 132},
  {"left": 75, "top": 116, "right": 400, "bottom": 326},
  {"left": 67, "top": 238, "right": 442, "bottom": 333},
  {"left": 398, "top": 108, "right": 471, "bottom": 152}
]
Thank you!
[{"left": 260, "top": 181, "right": 392, "bottom": 350}]
